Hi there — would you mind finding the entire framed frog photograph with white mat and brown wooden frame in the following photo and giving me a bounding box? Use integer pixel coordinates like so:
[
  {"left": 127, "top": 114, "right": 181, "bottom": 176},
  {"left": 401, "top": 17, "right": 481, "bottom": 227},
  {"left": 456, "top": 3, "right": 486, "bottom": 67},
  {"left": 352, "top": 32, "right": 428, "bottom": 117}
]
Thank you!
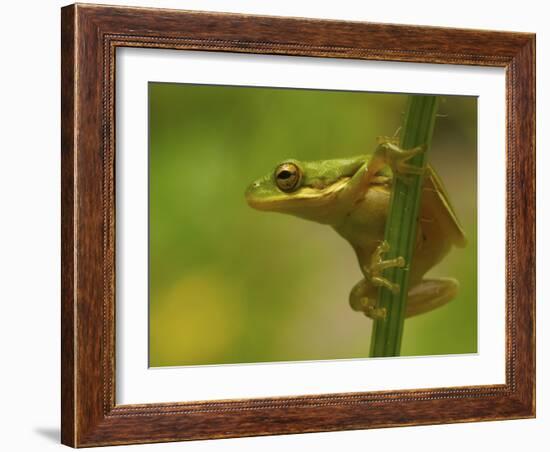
[{"left": 61, "top": 4, "right": 535, "bottom": 447}]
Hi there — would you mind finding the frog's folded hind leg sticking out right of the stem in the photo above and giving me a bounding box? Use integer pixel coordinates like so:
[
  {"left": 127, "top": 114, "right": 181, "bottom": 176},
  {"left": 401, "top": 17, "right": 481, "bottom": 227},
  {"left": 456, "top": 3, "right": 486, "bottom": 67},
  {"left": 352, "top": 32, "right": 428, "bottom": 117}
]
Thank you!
[{"left": 405, "top": 278, "right": 459, "bottom": 318}]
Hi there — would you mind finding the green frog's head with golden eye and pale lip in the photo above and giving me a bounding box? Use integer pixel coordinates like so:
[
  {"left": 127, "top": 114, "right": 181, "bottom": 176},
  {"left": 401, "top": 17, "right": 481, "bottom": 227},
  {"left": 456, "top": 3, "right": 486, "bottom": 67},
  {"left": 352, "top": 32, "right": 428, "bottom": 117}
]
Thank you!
[{"left": 245, "top": 156, "right": 365, "bottom": 223}]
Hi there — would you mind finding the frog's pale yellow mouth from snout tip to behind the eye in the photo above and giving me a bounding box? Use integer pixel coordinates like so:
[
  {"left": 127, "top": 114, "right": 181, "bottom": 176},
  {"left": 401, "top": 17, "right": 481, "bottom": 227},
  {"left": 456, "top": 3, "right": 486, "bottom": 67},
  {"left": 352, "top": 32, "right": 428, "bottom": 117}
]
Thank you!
[{"left": 245, "top": 176, "right": 350, "bottom": 213}]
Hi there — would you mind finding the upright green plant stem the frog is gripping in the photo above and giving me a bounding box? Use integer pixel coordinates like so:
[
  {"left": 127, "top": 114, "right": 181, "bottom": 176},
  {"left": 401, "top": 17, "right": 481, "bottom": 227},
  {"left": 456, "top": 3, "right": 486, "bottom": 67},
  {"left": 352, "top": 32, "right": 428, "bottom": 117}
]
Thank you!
[{"left": 370, "top": 95, "right": 438, "bottom": 357}]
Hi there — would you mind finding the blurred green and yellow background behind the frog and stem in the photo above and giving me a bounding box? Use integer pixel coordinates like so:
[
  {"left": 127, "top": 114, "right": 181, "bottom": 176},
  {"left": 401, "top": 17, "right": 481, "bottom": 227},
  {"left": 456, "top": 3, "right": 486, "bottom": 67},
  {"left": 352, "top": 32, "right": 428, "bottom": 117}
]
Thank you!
[{"left": 149, "top": 83, "right": 477, "bottom": 367}]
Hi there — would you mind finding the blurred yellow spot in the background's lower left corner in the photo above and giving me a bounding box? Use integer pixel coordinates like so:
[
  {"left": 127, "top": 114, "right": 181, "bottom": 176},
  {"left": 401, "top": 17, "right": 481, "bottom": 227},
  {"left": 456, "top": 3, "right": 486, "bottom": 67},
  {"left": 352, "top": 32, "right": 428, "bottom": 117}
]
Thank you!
[{"left": 150, "top": 273, "right": 242, "bottom": 367}]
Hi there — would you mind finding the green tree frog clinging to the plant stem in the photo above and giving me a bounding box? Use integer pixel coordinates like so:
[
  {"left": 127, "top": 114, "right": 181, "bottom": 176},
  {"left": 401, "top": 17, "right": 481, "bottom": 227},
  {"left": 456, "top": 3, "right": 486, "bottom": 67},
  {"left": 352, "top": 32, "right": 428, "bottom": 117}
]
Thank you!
[{"left": 245, "top": 137, "right": 467, "bottom": 320}]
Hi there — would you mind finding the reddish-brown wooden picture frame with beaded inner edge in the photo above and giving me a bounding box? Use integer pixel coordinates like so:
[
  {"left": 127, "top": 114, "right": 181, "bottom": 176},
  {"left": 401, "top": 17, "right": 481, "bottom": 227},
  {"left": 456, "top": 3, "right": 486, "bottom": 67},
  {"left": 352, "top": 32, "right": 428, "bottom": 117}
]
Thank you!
[{"left": 61, "top": 4, "right": 535, "bottom": 447}]
